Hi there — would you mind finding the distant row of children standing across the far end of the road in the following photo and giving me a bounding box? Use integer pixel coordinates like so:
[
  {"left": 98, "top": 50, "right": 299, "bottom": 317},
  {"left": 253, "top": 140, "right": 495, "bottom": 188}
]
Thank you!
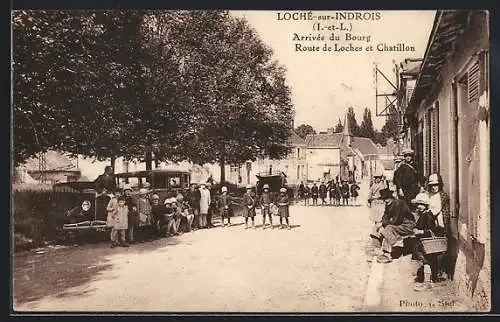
[{"left": 298, "top": 178, "right": 360, "bottom": 206}]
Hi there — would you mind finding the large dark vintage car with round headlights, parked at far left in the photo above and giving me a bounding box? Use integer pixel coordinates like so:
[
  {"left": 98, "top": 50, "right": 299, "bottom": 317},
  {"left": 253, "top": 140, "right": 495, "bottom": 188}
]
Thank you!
[{"left": 53, "top": 169, "right": 191, "bottom": 240}]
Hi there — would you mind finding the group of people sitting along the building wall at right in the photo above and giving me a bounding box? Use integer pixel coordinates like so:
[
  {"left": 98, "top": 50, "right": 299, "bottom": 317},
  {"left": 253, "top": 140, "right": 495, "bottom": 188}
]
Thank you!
[{"left": 368, "top": 174, "right": 454, "bottom": 291}]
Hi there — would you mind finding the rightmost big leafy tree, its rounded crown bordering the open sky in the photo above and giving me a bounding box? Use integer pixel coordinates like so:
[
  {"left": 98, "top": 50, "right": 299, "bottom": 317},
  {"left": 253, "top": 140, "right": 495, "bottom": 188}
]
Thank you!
[{"left": 176, "top": 12, "right": 293, "bottom": 183}]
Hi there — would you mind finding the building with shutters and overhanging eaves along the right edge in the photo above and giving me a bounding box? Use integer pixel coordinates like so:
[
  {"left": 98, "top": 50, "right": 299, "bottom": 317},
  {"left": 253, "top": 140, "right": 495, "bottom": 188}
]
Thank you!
[{"left": 405, "top": 10, "right": 491, "bottom": 310}]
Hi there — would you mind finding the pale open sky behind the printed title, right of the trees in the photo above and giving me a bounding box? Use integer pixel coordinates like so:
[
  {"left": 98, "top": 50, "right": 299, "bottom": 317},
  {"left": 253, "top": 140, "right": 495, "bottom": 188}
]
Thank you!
[{"left": 231, "top": 11, "right": 435, "bottom": 131}]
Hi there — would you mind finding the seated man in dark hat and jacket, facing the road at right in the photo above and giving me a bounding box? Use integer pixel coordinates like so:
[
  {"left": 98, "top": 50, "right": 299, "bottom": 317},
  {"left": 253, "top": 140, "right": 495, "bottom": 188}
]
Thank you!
[{"left": 376, "top": 188, "right": 415, "bottom": 263}]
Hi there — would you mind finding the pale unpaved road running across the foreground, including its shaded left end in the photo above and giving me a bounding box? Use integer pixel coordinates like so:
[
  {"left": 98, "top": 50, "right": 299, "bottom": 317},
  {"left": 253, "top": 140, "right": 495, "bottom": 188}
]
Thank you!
[{"left": 14, "top": 196, "right": 376, "bottom": 312}]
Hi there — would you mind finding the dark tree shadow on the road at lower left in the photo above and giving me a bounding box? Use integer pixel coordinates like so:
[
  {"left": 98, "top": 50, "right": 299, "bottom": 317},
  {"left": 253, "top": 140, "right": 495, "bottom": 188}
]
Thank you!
[{"left": 12, "top": 237, "right": 185, "bottom": 305}]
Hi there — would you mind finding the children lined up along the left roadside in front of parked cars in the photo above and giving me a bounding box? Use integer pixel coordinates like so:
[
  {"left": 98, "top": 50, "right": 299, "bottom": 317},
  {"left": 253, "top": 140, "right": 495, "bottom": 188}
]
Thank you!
[{"left": 106, "top": 184, "right": 291, "bottom": 248}]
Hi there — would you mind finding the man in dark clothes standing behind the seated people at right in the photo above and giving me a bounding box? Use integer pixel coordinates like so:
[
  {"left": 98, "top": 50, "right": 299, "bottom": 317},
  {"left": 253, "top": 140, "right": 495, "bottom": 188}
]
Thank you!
[{"left": 393, "top": 149, "right": 420, "bottom": 207}]
